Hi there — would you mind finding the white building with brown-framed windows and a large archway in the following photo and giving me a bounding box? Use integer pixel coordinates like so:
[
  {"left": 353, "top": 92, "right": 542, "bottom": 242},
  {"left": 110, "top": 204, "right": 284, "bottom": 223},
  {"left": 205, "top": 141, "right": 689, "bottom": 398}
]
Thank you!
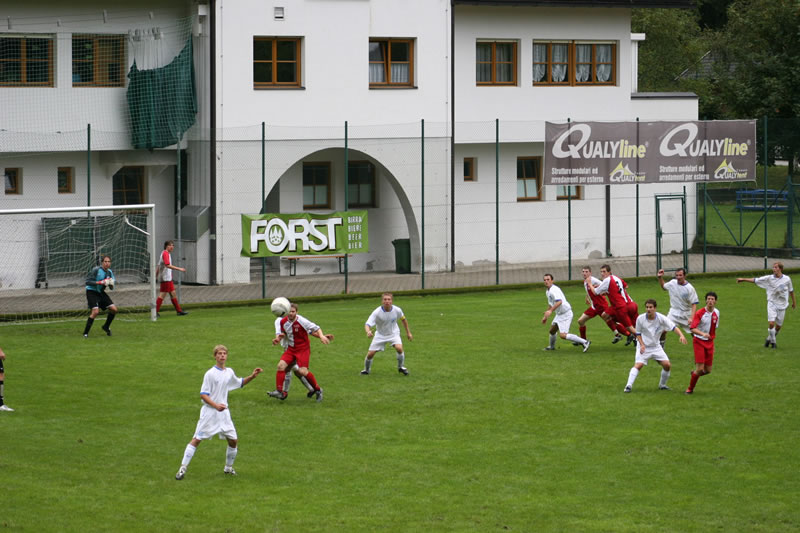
[{"left": 0, "top": 0, "right": 697, "bottom": 283}]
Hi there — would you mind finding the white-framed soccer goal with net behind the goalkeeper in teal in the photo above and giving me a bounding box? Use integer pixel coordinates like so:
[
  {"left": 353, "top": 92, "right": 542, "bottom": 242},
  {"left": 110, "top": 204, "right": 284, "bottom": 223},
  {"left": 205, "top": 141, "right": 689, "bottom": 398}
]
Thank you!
[{"left": 0, "top": 204, "right": 157, "bottom": 323}]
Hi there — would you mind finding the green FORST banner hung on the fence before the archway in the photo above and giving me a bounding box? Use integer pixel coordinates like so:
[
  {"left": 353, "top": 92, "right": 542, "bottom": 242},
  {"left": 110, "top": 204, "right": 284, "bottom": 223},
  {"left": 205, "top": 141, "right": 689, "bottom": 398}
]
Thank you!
[{"left": 242, "top": 211, "right": 369, "bottom": 257}]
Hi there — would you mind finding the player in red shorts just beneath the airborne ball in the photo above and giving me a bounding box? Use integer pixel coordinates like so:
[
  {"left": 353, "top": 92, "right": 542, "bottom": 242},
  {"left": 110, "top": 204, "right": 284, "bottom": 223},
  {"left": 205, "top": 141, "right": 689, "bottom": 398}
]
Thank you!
[{"left": 269, "top": 303, "right": 333, "bottom": 402}]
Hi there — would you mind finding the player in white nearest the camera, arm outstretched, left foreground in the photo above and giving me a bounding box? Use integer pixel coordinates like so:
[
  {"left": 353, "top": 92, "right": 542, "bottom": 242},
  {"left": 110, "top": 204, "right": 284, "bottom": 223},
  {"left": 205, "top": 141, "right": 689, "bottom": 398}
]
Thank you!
[{"left": 175, "top": 344, "right": 261, "bottom": 480}]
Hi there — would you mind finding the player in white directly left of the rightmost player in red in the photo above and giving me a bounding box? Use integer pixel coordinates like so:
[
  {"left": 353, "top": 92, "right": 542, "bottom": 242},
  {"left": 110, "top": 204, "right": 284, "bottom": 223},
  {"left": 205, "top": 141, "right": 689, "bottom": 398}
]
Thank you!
[{"left": 623, "top": 298, "right": 686, "bottom": 392}]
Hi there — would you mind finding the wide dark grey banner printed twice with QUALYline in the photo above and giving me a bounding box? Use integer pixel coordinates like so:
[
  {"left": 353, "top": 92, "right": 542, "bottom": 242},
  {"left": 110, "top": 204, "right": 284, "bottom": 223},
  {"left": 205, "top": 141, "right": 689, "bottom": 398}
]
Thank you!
[{"left": 543, "top": 120, "right": 756, "bottom": 185}]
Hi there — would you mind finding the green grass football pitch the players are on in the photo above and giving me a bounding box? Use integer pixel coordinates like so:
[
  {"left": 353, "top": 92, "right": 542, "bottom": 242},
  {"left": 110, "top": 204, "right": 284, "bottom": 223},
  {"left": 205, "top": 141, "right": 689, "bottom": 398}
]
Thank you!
[{"left": 0, "top": 277, "right": 800, "bottom": 532}]
